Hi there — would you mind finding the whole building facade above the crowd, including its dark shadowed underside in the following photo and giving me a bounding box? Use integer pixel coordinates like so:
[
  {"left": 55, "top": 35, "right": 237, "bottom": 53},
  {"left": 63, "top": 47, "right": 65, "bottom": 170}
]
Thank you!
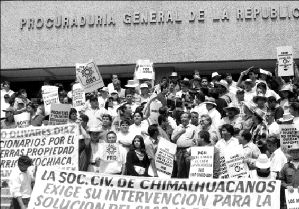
[{"left": 1, "top": 1, "right": 299, "bottom": 86}]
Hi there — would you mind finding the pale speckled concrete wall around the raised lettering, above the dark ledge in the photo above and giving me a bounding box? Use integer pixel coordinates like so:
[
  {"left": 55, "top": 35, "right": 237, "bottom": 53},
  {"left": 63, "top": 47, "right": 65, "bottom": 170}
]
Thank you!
[{"left": 1, "top": 1, "right": 299, "bottom": 69}]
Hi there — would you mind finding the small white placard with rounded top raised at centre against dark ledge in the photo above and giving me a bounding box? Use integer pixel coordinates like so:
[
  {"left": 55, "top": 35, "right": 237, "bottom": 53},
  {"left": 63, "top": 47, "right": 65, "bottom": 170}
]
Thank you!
[{"left": 135, "top": 60, "right": 155, "bottom": 80}]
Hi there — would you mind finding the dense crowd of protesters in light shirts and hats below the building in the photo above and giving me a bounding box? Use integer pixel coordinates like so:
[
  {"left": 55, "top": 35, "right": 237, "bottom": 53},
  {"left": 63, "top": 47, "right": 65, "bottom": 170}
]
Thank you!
[{"left": 1, "top": 64, "right": 299, "bottom": 207}]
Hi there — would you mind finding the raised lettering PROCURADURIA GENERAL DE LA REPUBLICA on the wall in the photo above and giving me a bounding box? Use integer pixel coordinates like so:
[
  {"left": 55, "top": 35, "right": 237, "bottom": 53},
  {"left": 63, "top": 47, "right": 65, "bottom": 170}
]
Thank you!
[{"left": 20, "top": 6, "right": 299, "bottom": 30}]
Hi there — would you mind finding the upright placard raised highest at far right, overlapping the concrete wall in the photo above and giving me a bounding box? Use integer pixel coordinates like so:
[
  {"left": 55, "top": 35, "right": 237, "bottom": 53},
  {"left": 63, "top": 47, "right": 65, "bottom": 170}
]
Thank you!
[{"left": 277, "top": 46, "right": 294, "bottom": 76}]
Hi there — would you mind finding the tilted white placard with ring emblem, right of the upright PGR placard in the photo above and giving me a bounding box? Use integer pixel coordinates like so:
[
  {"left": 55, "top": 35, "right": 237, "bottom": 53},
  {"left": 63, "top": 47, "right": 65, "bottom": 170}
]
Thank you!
[{"left": 225, "top": 145, "right": 249, "bottom": 178}]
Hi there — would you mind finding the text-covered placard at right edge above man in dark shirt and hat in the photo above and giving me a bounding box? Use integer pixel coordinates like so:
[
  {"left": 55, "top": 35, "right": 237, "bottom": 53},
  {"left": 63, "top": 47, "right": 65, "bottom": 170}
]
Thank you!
[{"left": 279, "top": 124, "right": 299, "bottom": 152}]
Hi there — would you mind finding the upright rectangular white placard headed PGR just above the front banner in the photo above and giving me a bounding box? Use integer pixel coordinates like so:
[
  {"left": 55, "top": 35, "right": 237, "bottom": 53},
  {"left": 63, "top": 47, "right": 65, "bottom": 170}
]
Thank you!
[{"left": 189, "top": 147, "right": 214, "bottom": 178}]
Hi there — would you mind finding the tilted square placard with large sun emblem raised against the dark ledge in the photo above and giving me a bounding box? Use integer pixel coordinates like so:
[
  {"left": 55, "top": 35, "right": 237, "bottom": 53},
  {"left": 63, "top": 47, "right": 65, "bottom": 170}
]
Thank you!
[{"left": 76, "top": 61, "right": 105, "bottom": 93}]
